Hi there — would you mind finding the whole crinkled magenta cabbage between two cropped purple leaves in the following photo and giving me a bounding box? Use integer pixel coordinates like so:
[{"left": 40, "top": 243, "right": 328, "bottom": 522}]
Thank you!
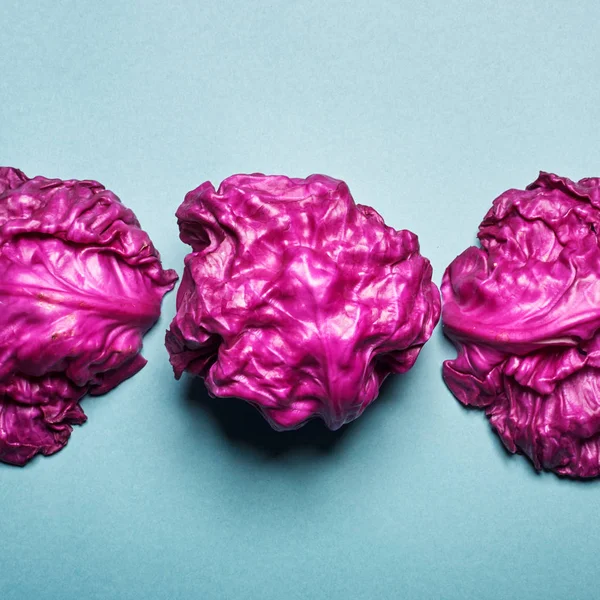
[{"left": 166, "top": 174, "right": 440, "bottom": 429}]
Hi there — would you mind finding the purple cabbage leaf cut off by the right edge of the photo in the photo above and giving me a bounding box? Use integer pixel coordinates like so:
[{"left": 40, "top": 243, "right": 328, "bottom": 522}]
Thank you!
[{"left": 442, "top": 173, "right": 600, "bottom": 477}]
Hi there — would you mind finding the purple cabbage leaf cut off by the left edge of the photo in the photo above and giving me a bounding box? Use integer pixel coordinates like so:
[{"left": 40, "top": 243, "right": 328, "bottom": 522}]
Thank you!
[{"left": 0, "top": 168, "right": 177, "bottom": 465}]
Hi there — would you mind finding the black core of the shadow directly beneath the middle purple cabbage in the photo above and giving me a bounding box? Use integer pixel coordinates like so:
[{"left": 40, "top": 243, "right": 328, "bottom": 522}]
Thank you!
[{"left": 184, "top": 376, "right": 354, "bottom": 458}]
